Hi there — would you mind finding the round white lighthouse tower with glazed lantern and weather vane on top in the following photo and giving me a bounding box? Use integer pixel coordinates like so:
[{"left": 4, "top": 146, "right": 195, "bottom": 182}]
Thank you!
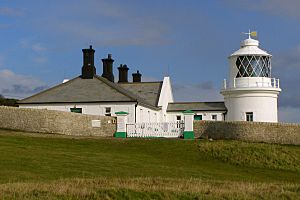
[{"left": 221, "top": 31, "right": 281, "bottom": 122}]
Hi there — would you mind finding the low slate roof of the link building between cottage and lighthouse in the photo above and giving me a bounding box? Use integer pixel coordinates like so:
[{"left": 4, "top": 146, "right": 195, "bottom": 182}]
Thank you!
[{"left": 167, "top": 102, "right": 227, "bottom": 112}]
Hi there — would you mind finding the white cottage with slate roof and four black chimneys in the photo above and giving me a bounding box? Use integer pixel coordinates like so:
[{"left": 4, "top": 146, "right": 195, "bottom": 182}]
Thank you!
[{"left": 18, "top": 46, "right": 174, "bottom": 123}]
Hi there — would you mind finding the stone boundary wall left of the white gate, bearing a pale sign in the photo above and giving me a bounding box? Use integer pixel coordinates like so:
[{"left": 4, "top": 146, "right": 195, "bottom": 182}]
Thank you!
[{"left": 0, "top": 106, "right": 116, "bottom": 137}]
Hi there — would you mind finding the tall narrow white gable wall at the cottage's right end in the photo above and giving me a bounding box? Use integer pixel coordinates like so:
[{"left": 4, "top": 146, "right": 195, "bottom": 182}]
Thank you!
[{"left": 158, "top": 77, "right": 174, "bottom": 122}]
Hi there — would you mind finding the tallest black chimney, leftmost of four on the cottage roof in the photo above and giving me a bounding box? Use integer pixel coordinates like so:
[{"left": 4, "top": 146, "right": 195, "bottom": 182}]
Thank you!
[{"left": 81, "top": 45, "right": 96, "bottom": 79}]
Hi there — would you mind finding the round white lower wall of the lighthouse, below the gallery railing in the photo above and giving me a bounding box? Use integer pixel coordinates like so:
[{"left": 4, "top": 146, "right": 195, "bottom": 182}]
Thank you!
[{"left": 222, "top": 89, "right": 279, "bottom": 122}]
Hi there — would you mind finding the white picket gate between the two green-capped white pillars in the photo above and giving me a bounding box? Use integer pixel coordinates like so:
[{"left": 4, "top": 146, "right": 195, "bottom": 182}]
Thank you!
[{"left": 126, "top": 121, "right": 184, "bottom": 138}]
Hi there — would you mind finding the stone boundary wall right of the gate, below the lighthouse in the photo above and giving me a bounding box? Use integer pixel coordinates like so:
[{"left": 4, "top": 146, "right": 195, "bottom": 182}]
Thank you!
[{"left": 194, "top": 121, "right": 300, "bottom": 145}]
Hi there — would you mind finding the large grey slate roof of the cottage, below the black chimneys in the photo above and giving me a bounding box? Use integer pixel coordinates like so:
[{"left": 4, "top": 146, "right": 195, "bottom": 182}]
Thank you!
[{"left": 18, "top": 75, "right": 161, "bottom": 109}]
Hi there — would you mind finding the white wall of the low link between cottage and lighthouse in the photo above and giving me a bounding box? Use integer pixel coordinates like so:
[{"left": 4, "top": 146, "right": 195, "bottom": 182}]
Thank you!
[{"left": 168, "top": 111, "right": 225, "bottom": 122}]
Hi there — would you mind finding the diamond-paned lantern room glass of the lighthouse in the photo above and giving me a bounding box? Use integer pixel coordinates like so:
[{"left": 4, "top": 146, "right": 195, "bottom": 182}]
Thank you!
[{"left": 235, "top": 55, "right": 271, "bottom": 78}]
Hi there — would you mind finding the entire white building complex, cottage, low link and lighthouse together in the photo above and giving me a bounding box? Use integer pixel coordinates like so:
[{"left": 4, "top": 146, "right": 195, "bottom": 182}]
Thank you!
[{"left": 19, "top": 33, "right": 281, "bottom": 123}]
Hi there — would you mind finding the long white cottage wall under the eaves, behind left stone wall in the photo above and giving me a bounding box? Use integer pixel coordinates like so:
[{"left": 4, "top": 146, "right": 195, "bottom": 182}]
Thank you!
[{"left": 20, "top": 103, "right": 135, "bottom": 123}]
